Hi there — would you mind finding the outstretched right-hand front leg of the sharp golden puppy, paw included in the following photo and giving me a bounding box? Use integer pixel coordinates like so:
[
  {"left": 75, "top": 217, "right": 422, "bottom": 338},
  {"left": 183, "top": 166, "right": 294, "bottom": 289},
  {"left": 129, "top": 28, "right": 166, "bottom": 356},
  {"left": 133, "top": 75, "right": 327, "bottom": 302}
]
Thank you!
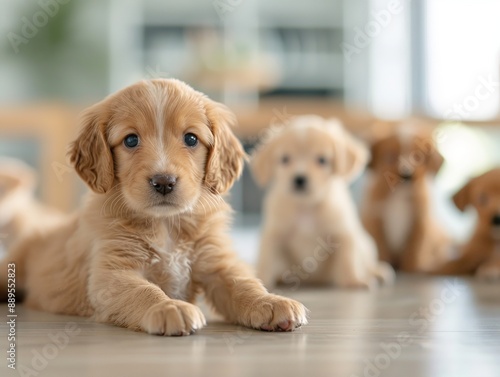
[{"left": 192, "top": 243, "right": 307, "bottom": 331}]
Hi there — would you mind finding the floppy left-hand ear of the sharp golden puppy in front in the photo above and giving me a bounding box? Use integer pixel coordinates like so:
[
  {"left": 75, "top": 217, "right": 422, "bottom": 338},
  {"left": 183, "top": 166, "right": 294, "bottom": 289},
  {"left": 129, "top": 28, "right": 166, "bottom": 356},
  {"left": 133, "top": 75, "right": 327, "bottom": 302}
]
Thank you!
[{"left": 68, "top": 100, "right": 115, "bottom": 194}]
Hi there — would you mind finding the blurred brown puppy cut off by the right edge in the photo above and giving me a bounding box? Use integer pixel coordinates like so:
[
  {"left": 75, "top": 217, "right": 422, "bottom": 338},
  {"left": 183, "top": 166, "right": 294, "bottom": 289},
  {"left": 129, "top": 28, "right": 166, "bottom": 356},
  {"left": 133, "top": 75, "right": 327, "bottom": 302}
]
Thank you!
[{"left": 435, "top": 168, "right": 500, "bottom": 280}]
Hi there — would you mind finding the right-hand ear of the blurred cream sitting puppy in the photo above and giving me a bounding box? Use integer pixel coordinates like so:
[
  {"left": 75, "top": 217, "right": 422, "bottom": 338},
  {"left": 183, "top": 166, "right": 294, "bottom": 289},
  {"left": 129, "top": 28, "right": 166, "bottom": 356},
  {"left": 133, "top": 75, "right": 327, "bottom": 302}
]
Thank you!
[{"left": 328, "top": 119, "right": 370, "bottom": 182}]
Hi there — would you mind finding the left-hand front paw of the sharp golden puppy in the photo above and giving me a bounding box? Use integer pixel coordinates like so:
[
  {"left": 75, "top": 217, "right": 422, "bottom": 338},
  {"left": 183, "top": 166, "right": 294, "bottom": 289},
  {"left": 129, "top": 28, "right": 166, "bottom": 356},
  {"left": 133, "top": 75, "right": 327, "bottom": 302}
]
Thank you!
[{"left": 141, "top": 300, "right": 206, "bottom": 336}]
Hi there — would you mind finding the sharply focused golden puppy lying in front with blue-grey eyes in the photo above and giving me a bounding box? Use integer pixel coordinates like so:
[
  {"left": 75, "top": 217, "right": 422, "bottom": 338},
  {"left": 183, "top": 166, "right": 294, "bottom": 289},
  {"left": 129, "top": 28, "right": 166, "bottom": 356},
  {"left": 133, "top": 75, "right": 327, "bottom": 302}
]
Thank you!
[{"left": 0, "top": 80, "right": 307, "bottom": 335}]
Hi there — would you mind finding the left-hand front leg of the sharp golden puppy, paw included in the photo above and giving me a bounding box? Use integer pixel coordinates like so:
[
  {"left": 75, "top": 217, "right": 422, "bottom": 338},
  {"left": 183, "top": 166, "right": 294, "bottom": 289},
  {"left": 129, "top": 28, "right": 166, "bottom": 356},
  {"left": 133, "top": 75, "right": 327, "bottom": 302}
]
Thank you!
[{"left": 89, "top": 258, "right": 205, "bottom": 336}]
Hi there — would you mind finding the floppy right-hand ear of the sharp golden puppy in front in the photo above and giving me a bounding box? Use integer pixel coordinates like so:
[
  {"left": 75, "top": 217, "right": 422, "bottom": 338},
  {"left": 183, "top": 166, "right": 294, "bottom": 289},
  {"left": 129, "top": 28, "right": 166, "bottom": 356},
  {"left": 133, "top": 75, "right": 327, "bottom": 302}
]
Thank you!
[{"left": 204, "top": 97, "right": 246, "bottom": 194}]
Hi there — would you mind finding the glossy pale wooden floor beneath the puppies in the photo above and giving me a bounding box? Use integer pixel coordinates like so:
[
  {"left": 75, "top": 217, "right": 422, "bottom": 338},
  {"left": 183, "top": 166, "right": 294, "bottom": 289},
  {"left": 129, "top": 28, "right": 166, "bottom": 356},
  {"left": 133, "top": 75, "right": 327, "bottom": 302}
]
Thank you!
[{"left": 0, "top": 276, "right": 500, "bottom": 377}]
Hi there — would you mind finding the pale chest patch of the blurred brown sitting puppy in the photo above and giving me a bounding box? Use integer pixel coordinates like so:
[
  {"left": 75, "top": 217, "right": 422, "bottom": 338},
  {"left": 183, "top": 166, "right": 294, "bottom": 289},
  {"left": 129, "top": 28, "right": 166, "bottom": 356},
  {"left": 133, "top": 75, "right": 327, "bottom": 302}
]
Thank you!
[{"left": 382, "top": 184, "right": 414, "bottom": 252}]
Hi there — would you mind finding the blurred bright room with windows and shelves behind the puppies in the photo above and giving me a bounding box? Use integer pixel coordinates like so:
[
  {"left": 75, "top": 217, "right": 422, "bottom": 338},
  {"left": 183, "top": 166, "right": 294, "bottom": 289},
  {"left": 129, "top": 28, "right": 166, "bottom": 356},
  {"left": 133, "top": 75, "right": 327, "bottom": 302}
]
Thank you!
[{"left": 0, "top": 0, "right": 500, "bottom": 261}]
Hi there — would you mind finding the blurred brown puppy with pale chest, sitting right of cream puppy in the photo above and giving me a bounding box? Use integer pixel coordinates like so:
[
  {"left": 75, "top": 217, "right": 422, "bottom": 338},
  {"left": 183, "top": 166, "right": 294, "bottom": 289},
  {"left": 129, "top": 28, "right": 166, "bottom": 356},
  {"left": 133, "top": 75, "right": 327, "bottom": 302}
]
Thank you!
[{"left": 362, "top": 123, "right": 451, "bottom": 272}]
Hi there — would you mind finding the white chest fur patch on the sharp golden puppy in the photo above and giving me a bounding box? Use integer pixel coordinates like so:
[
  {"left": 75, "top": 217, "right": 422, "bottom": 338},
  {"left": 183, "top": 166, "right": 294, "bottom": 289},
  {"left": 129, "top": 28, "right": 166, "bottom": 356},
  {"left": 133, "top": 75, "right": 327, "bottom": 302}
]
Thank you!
[{"left": 146, "top": 240, "right": 192, "bottom": 300}]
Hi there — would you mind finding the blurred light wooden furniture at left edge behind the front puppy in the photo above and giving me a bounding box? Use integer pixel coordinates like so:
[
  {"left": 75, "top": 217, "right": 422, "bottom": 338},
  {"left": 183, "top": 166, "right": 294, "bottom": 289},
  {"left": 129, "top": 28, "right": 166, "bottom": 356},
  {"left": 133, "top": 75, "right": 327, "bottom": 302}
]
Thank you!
[{"left": 0, "top": 104, "right": 78, "bottom": 211}]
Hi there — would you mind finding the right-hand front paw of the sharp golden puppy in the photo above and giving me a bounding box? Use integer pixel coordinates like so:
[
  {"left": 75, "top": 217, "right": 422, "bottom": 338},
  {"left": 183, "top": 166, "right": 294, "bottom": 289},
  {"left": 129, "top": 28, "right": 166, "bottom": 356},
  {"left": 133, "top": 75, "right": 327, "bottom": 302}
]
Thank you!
[{"left": 241, "top": 294, "right": 307, "bottom": 331}]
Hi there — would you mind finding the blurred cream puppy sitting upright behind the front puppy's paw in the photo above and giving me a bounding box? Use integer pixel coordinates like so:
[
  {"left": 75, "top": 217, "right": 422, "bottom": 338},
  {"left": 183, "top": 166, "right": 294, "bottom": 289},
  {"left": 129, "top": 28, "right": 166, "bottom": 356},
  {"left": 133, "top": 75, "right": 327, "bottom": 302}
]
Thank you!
[{"left": 252, "top": 115, "right": 394, "bottom": 287}]
